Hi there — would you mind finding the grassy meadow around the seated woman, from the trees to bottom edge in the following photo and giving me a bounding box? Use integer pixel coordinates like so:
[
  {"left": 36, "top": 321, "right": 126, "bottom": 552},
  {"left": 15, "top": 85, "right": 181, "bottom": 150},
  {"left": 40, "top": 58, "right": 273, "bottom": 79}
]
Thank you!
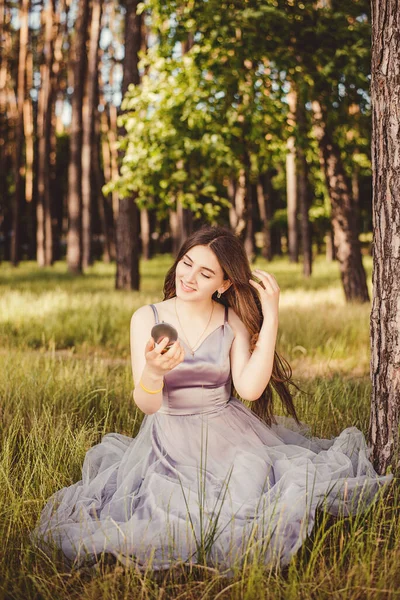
[{"left": 0, "top": 256, "right": 400, "bottom": 600}]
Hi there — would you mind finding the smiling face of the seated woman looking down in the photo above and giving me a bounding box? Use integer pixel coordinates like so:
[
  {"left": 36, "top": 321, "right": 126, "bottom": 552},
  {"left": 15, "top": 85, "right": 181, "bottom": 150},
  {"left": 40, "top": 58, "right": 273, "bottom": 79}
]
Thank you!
[{"left": 175, "top": 246, "right": 229, "bottom": 300}]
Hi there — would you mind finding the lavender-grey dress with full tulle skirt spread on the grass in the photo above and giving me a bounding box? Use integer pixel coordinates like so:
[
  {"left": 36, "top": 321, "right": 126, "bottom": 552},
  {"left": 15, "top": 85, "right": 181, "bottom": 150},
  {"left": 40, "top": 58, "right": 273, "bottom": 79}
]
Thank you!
[{"left": 33, "top": 305, "right": 392, "bottom": 572}]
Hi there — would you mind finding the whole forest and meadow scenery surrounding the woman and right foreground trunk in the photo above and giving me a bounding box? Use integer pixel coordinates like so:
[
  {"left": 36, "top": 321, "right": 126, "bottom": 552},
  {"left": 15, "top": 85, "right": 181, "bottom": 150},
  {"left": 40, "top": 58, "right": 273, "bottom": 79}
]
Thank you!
[{"left": 0, "top": 0, "right": 400, "bottom": 600}]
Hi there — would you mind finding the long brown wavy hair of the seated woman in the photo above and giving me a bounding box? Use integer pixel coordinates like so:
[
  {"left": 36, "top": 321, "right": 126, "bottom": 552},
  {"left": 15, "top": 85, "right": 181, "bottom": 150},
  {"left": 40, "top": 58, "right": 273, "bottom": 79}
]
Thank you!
[{"left": 163, "top": 225, "right": 299, "bottom": 425}]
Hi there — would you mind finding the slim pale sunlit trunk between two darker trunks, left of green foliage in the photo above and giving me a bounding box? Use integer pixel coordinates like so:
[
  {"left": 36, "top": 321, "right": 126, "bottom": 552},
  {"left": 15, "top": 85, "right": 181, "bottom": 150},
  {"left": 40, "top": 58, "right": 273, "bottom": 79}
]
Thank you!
[{"left": 82, "top": 0, "right": 103, "bottom": 268}]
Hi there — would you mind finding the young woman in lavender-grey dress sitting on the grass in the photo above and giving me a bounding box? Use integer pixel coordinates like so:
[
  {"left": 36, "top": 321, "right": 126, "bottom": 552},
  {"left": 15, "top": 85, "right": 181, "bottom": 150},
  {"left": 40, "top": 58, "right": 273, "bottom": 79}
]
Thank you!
[{"left": 35, "top": 227, "right": 391, "bottom": 569}]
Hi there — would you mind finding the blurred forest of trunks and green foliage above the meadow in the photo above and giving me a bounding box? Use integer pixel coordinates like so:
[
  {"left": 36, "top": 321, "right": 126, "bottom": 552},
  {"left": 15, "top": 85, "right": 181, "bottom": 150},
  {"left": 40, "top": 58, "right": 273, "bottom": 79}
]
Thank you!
[{"left": 0, "top": 0, "right": 372, "bottom": 301}]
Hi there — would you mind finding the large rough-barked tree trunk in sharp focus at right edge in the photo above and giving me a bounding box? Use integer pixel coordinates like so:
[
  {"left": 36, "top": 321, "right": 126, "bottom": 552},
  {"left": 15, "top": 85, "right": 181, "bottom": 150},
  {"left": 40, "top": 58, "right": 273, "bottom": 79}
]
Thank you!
[{"left": 369, "top": 0, "right": 400, "bottom": 474}]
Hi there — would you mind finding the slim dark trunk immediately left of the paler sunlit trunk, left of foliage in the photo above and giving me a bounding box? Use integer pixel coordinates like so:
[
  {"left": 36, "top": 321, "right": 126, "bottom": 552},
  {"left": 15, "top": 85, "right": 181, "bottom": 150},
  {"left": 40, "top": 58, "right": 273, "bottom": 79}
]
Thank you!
[{"left": 67, "top": 0, "right": 89, "bottom": 273}]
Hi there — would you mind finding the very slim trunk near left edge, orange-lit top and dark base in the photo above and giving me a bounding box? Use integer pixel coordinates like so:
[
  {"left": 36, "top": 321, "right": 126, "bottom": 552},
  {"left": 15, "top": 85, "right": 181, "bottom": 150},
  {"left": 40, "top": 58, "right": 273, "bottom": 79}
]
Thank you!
[{"left": 11, "top": 0, "right": 30, "bottom": 266}]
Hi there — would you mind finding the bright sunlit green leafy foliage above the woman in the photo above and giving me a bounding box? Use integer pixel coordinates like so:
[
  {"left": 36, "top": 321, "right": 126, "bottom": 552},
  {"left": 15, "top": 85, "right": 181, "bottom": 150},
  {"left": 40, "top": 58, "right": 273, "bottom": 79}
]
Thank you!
[{"left": 107, "top": 0, "right": 370, "bottom": 230}]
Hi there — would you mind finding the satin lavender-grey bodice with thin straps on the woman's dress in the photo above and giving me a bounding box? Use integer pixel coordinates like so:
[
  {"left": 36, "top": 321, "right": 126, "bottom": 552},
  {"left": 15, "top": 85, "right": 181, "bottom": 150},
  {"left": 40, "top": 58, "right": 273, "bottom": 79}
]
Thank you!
[{"left": 150, "top": 304, "right": 235, "bottom": 415}]
